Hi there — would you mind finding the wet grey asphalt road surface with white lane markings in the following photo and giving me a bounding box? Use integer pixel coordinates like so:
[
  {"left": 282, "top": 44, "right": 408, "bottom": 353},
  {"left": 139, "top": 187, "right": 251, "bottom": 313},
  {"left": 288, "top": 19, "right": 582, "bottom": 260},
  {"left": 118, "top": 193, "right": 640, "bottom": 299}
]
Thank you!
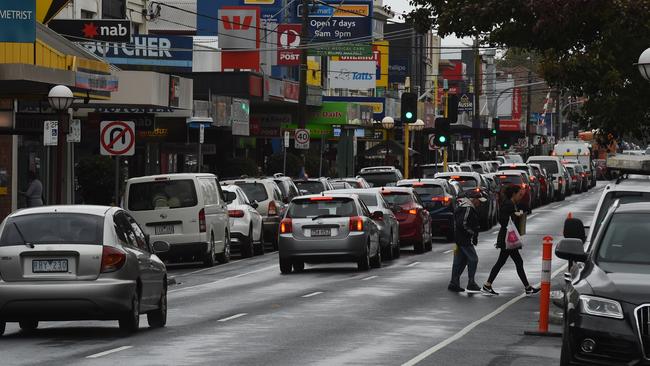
[{"left": 0, "top": 183, "right": 604, "bottom": 366}]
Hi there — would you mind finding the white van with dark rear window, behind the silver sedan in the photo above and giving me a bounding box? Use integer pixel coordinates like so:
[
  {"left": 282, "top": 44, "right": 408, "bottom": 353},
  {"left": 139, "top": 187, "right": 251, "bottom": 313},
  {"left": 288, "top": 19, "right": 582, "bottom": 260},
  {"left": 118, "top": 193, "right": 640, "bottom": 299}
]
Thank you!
[{"left": 124, "top": 173, "right": 230, "bottom": 266}]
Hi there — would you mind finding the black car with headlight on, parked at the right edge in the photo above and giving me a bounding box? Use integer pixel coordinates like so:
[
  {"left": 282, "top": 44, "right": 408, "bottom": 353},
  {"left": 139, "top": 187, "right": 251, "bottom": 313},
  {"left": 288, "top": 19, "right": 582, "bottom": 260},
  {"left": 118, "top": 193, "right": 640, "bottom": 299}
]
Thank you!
[{"left": 555, "top": 201, "right": 650, "bottom": 366}]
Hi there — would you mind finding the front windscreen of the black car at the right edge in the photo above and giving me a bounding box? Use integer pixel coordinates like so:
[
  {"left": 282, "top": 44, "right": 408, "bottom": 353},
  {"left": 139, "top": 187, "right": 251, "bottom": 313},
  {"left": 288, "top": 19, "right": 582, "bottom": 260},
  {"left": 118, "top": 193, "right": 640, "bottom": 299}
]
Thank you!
[{"left": 596, "top": 213, "right": 650, "bottom": 265}]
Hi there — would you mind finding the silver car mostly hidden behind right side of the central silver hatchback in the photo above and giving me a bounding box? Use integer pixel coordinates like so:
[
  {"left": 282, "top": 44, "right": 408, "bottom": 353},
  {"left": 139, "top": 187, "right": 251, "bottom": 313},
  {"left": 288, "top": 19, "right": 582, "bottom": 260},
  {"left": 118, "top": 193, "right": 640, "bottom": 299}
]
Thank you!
[{"left": 325, "top": 188, "right": 400, "bottom": 260}]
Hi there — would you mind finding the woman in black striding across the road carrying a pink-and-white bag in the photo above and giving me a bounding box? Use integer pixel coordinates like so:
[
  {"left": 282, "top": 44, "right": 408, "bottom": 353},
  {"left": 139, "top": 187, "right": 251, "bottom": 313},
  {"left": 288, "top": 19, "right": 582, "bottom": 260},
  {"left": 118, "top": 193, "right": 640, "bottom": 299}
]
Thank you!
[{"left": 481, "top": 185, "right": 540, "bottom": 296}]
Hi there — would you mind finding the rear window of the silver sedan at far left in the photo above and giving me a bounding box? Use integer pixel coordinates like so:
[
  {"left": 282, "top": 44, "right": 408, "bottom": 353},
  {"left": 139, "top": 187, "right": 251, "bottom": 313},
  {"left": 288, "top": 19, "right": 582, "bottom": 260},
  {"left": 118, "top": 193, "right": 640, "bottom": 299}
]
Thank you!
[{"left": 0, "top": 213, "right": 104, "bottom": 247}]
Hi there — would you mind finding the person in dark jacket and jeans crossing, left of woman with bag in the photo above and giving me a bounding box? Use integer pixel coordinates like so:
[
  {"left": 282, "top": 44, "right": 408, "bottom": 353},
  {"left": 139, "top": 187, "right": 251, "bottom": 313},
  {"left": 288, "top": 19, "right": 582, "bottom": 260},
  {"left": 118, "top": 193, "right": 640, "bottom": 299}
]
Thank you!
[{"left": 447, "top": 190, "right": 487, "bottom": 293}]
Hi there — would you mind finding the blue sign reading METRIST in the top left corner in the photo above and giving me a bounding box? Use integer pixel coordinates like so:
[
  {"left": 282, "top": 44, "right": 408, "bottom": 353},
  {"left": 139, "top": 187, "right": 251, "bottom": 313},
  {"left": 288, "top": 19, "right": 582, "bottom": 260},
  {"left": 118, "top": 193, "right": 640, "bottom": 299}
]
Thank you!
[{"left": 0, "top": 0, "right": 36, "bottom": 43}]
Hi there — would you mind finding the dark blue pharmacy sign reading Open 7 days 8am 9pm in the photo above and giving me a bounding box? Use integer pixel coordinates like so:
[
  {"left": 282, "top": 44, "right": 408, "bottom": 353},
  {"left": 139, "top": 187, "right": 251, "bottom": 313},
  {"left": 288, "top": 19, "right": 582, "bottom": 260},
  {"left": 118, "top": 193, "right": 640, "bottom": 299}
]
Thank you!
[{"left": 296, "top": 0, "right": 373, "bottom": 43}]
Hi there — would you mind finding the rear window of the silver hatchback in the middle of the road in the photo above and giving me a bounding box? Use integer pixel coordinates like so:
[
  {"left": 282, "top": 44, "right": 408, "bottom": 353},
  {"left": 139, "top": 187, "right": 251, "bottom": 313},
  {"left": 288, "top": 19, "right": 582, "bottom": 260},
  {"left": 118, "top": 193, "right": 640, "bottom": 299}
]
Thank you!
[{"left": 287, "top": 196, "right": 357, "bottom": 219}]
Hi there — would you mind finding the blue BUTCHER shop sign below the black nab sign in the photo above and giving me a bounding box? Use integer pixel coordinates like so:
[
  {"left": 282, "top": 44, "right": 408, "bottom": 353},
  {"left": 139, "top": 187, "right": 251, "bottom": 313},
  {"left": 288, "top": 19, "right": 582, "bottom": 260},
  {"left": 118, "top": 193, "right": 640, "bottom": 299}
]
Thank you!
[{"left": 80, "top": 35, "right": 192, "bottom": 71}]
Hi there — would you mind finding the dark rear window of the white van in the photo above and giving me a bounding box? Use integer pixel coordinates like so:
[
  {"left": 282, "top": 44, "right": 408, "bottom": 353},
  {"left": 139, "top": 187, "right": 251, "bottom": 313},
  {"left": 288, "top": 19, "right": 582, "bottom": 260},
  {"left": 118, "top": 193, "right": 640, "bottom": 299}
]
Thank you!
[{"left": 129, "top": 179, "right": 198, "bottom": 211}]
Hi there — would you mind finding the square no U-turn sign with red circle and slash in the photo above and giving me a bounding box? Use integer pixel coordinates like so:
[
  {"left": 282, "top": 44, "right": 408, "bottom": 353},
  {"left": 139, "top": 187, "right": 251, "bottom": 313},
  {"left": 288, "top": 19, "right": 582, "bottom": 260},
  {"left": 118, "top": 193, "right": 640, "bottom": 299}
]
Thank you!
[{"left": 99, "top": 121, "right": 135, "bottom": 156}]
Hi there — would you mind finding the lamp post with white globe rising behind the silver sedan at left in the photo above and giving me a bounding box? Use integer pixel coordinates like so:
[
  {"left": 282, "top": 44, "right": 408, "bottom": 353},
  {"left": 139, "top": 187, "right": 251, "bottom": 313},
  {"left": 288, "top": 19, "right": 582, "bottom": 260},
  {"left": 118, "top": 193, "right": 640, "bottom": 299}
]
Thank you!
[{"left": 47, "top": 85, "right": 74, "bottom": 205}]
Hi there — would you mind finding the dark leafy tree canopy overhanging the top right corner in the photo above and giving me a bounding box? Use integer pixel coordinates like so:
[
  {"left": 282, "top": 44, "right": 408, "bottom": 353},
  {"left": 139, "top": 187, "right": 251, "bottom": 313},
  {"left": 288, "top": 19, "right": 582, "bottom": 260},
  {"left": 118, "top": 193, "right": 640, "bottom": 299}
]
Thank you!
[{"left": 408, "top": 0, "right": 650, "bottom": 137}]
